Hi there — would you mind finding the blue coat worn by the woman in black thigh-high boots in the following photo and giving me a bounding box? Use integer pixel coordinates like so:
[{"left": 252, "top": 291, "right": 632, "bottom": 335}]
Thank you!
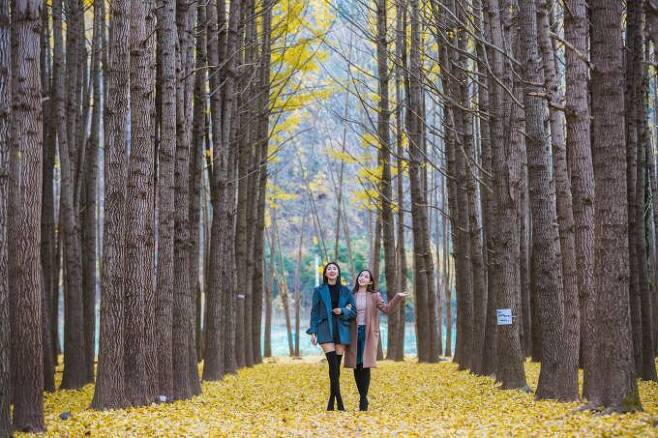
[{"left": 306, "top": 284, "right": 356, "bottom": 345}]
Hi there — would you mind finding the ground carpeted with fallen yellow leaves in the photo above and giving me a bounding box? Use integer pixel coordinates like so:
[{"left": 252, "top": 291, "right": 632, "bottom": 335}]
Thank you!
[{"left": 18, "top": 357, "right": 658, "bottom": 436}]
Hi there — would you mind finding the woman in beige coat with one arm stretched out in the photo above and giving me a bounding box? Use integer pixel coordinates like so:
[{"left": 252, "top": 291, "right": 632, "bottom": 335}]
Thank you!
[{"left": 345, "top": 270, "right": 407, "bottom": 411}]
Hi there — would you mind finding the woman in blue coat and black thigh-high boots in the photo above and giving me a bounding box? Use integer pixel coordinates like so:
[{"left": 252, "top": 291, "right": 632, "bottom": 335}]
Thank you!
[{"left": 306, "top": 262, "right": 356, "bottom": 411}]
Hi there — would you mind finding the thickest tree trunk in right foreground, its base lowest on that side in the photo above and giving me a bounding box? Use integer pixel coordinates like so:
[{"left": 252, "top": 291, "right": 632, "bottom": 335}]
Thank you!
[{"left": 588, "top": 0, "right": 641, "bottom": 411}]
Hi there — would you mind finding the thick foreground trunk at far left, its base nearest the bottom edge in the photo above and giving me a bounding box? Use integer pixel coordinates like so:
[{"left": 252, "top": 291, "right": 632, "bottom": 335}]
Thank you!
[{"left": 9, "top": 0, "right": 45, "bottom": 432}]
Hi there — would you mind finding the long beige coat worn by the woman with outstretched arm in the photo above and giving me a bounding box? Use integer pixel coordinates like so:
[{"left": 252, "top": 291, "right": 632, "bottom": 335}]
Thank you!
[{"left": 345, "top": 292, "right": 404, "bottom": 368}]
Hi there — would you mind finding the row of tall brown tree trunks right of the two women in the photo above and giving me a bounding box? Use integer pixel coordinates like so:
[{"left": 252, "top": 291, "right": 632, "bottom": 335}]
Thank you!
[{"left": 394, "top": 0, "right": 657, "bottom": 411}]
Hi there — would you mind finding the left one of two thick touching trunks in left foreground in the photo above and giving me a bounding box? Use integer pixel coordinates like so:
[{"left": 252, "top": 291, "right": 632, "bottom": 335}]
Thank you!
[{"left": 91, "top": 0, "right": 131, "bottom": 409}]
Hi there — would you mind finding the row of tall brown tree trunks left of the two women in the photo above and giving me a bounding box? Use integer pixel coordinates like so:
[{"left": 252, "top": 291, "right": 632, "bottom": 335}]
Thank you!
[{"left": 0, "top": 0, "right": 274, "bottom": 436}]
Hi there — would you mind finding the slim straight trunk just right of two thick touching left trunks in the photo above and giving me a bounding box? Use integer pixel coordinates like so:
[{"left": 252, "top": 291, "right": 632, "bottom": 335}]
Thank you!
[{"left": 156, "top": 0, "right": 179, "bottom": 400}]
